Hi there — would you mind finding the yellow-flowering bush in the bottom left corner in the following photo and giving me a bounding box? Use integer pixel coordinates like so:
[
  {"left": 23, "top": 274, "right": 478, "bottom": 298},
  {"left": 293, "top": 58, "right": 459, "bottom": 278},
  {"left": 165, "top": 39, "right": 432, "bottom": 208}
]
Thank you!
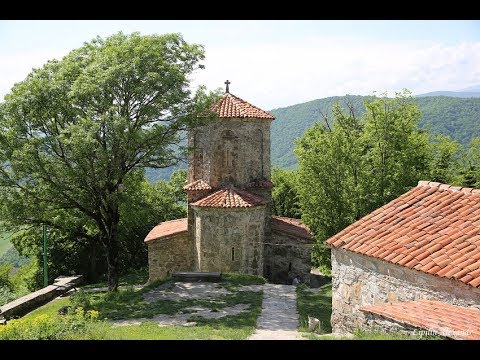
[{"left": 0, "top": 308, "right": 99, "bottom": 340}]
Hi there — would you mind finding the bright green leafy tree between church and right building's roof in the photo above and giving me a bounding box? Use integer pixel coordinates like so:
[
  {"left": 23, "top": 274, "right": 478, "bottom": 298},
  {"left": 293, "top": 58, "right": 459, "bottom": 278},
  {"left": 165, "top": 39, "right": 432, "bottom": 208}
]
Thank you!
[{"left": 295, "top": 91, "right": 431, "bottom": 268}]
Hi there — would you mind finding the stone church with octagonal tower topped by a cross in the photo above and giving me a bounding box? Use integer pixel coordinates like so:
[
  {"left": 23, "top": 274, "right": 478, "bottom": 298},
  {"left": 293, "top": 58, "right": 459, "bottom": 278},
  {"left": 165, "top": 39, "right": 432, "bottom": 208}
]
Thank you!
[{"left": 145, "top": 81, "right": 313, "bottom": 283}]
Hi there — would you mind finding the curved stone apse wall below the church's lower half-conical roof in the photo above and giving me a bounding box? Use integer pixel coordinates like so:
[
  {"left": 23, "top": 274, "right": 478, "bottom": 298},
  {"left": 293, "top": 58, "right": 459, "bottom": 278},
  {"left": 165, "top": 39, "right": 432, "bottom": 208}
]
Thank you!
[{"left": 192, "top": 206, "right": 266, "bottom": 276}]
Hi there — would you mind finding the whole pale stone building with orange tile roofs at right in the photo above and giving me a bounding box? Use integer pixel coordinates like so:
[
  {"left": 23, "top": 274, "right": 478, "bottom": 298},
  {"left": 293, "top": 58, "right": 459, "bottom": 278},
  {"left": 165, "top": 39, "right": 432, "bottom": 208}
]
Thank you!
[{"left": 326, "top": 181, "right": 480, "bottom": 339}]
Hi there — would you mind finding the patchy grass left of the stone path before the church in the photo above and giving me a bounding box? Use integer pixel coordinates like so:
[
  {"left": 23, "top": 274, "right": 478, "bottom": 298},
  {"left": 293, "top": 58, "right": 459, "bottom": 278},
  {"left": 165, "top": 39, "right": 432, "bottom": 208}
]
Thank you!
[{"left": 14, "top": 274, "right": 265, "bottom": 340}]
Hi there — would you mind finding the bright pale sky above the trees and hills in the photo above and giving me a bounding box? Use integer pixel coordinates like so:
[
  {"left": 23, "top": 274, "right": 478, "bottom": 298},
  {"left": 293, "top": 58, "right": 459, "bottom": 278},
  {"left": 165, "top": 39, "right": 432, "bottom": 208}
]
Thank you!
[{"left": 0, "top": 20, "right": 480, "bottom": 110}]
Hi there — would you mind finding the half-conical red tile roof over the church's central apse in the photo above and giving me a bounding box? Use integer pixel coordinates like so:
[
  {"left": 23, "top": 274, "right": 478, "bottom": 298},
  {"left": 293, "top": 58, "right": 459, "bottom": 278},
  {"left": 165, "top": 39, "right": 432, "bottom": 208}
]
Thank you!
[{"left": 191, "top": 187, "right": 267, "bottom": 208}]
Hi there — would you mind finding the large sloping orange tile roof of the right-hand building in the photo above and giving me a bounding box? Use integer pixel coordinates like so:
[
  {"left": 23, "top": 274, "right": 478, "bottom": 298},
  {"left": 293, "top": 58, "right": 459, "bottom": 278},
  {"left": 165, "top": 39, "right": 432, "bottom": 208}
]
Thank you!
[{"left": 326, "top": 181, "right": 480, "bottom": 287}]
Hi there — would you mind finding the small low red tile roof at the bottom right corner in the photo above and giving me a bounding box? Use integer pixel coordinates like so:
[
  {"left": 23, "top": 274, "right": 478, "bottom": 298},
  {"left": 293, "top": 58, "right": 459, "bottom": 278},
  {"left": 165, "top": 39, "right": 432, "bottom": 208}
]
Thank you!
[{"left": 360, "top": 300, "right": 480, "bottom": 340}]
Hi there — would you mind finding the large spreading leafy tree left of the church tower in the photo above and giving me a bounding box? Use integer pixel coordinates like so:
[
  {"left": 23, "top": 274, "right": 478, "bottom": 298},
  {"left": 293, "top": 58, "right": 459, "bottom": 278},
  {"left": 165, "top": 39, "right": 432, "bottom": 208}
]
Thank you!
[{"left": 0, "top": 33, "right": 212, "bottom": 290}]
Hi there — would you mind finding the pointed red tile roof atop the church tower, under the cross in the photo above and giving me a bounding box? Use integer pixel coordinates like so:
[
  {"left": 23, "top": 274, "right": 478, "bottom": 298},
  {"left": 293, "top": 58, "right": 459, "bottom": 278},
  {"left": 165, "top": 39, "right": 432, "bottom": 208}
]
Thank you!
[{"left": 213, "top": 93, "right": 275, "bottom": 120}]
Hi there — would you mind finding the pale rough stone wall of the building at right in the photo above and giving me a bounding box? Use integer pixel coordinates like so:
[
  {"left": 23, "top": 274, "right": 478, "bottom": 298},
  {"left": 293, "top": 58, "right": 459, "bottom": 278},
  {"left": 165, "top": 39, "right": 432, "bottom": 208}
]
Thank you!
[{"left": 331, "top": 249, "right": 480, "bottom": 333}]
